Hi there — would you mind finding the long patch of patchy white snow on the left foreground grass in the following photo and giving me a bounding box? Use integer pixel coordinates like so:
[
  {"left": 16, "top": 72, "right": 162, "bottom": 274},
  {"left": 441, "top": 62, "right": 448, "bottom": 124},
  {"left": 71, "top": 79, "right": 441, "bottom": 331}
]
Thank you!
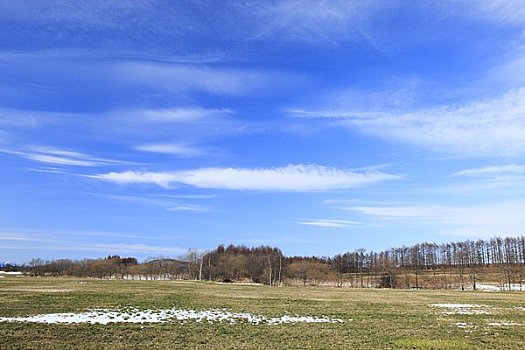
[{"left": 0, "top": 308, "right": 344, "bottom": 325}]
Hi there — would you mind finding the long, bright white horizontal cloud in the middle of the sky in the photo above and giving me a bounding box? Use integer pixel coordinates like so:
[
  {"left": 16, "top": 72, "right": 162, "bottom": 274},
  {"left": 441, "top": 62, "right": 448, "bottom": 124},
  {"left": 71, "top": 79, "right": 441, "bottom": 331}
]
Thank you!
[{"left": 87, "top": 164, "right": 400, "bottom": 191}]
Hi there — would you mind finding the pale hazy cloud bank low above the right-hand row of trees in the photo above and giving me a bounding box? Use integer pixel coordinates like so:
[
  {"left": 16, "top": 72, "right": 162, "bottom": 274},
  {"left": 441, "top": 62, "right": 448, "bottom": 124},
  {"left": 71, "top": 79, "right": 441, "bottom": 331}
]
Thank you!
[{"left": 345, "top": 201, "right": 525, "bottom": 237}]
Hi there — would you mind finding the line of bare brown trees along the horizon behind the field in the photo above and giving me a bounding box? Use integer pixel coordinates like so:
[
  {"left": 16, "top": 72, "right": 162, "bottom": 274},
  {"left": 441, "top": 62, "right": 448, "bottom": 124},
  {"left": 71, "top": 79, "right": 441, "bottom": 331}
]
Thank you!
[{"left": 20, "top": 236, "right": 525, "bottom": 289}]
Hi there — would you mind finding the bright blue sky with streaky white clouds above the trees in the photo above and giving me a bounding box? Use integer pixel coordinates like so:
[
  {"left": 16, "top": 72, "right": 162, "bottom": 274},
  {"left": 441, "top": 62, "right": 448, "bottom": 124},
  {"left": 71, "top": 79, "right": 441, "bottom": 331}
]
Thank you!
[{"left": 0, "top": 0, "right": 525, "bottom": 263}]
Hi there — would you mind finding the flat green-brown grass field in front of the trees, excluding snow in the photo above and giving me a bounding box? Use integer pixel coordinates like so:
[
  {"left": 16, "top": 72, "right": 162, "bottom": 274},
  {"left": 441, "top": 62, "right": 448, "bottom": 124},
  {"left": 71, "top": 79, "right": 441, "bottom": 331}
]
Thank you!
[{"left": 0, "top": 278, "right": 525, "bottom": 350}]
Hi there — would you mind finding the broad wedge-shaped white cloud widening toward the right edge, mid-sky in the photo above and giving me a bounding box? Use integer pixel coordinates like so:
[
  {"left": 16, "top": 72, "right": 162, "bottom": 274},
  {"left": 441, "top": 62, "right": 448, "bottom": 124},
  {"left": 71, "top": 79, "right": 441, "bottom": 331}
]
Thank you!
[{"left": 291, "top": 88, "right": 525, "bottom": 157}]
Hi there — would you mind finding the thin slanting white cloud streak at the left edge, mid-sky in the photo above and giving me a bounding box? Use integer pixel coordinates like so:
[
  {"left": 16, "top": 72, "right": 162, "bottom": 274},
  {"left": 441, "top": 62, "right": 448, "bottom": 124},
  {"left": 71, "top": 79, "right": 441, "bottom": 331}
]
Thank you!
[{"left": 0, "top": 147, "right": 130, "bottom": 167}]
